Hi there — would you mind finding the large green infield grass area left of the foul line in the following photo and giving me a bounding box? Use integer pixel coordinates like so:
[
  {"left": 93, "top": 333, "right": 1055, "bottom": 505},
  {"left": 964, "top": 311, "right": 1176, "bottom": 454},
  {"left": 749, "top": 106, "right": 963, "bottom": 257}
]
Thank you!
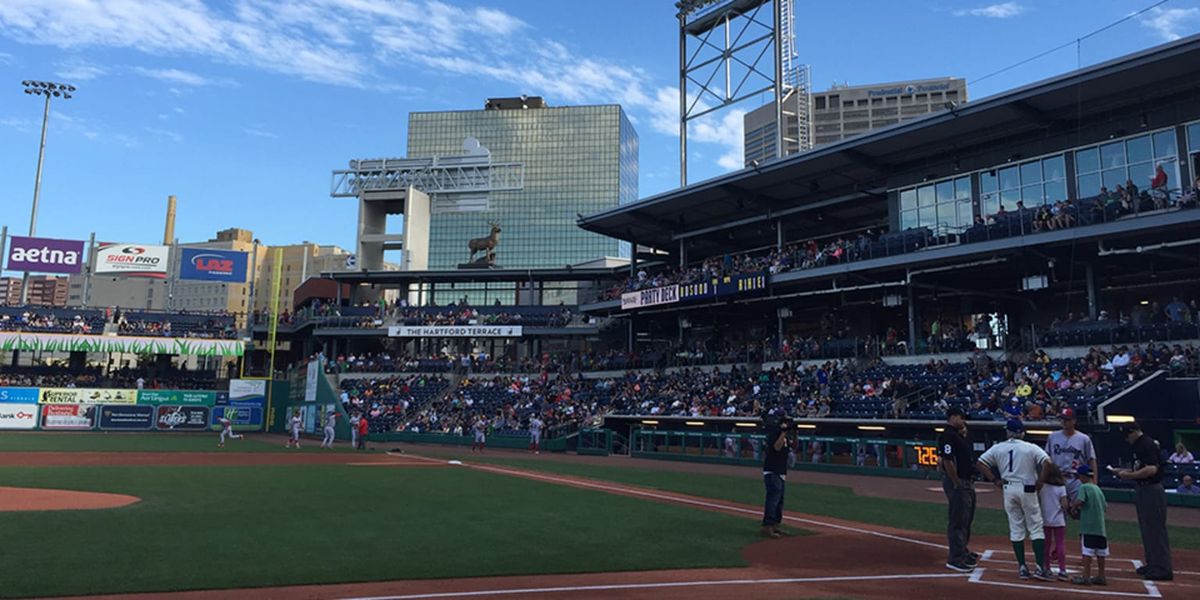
[{"left": 0, "top": 466, "right": 758, "bottom": 598}]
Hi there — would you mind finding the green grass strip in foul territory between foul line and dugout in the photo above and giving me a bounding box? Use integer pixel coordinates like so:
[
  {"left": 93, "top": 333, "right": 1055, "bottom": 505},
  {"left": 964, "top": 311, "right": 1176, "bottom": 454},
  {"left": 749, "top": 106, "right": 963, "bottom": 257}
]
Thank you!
[{"left": 462, "top": 454, "right": 1200, "bottom": 550}]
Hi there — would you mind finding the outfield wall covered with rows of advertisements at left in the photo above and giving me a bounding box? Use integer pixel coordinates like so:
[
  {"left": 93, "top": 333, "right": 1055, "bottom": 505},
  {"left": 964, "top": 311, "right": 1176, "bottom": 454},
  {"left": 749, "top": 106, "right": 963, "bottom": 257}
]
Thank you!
[{"left": 0, "top": 379, "right": 265, "bottom": 432}]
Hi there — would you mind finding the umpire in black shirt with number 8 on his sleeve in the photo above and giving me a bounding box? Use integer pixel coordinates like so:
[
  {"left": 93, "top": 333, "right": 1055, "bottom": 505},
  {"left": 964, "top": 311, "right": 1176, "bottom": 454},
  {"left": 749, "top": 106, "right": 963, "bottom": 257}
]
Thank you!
[{"left": 937, "top": 408, "right": 979, "bottom": 572}]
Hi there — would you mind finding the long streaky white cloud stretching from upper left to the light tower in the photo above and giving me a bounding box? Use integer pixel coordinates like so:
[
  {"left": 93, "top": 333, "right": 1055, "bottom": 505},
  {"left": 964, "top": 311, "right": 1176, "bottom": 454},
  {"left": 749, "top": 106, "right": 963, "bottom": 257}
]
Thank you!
[{"left": 0, "top": 0, "right": 734, "bottom": 168}]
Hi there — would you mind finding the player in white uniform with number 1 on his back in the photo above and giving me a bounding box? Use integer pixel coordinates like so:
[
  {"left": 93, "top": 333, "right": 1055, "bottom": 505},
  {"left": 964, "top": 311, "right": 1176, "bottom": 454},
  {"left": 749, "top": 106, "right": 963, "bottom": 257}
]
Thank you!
[{"left": 978, "top": 419, "right": 1054, "bottom": 581}]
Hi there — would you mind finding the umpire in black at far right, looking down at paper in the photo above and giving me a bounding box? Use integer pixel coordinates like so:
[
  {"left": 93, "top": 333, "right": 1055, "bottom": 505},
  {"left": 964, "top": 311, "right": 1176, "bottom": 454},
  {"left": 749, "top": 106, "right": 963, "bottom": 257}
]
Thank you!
[{"left": 1116, "top": 422, "right": 1175, "bottom": 581}]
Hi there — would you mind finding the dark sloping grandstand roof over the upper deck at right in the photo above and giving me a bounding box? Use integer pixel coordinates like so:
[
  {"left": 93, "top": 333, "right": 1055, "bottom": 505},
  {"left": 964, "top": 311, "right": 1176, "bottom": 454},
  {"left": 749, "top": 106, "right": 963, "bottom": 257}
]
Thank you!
[{"left": 578, "top": 35, "right": 1200, "bottom": 251}]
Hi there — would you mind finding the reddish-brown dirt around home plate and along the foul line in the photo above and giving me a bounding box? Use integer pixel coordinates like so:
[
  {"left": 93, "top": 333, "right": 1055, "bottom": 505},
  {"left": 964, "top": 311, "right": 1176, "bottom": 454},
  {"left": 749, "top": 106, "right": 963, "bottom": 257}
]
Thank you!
[{"left": 32, "top": 454, "right": 1200, "bottom": 600}]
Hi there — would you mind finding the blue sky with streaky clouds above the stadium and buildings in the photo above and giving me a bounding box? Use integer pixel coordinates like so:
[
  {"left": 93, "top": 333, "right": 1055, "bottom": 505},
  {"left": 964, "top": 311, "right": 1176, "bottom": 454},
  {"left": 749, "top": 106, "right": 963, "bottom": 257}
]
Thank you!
[{"left": 0, "top": 0, "right": 1200, "bottom": 255}]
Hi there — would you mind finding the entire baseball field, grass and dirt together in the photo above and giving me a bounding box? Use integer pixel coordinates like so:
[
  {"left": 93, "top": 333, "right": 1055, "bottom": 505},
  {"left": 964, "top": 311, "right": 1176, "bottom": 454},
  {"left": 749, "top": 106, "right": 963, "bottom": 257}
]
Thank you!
[{"left": 0, "top": 433, "right": 1200, "bottom": 600}]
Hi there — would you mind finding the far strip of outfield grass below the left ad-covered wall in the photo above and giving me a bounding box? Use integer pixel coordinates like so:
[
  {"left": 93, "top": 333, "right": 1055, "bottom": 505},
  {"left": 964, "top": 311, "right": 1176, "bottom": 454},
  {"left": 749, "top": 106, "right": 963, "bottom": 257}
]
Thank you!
[{"left": 0, "top": 432, "right": 352, "bottom": 454}]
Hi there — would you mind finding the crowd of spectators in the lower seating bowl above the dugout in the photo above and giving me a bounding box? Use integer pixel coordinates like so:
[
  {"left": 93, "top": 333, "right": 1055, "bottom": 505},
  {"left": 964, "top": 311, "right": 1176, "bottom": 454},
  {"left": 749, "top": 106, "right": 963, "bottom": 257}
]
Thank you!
[{"left": 328, "top": 344, "right": 1200, "bottom": 433}]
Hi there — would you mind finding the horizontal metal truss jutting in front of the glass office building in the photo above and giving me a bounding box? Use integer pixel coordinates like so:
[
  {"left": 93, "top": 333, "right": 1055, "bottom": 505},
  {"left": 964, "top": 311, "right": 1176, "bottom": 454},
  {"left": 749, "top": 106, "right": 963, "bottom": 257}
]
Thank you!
[{"left": 329, "top": 157, "right": 524, "bottom": 198}]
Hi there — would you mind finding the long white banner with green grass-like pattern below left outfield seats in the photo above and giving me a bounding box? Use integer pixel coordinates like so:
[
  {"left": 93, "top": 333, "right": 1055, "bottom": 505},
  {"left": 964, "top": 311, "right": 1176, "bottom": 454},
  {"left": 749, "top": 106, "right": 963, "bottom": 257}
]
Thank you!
[{"left": 0, "top": 331, "right": 245, "bottom": 356}]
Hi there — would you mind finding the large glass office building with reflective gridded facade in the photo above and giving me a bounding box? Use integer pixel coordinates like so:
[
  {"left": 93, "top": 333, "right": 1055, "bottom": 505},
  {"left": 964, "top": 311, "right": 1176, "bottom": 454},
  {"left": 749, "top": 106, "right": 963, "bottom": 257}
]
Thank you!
[{"left": 408, "top": 102, "right": 638, "bottom": 269}]
